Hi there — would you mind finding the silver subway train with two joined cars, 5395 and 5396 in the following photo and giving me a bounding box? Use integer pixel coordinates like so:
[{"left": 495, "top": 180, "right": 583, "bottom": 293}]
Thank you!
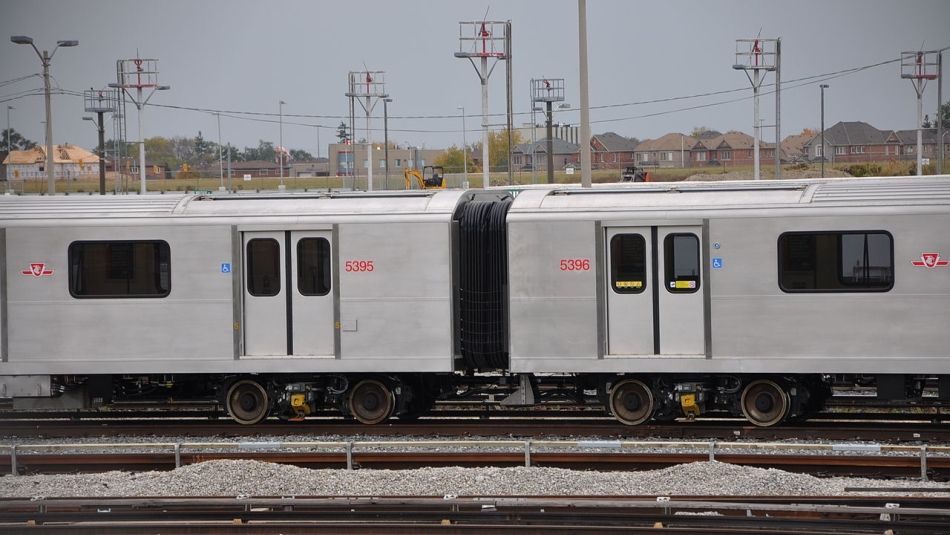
[{"left": 0, "top": 176, "right": 950, "bottom": 426}]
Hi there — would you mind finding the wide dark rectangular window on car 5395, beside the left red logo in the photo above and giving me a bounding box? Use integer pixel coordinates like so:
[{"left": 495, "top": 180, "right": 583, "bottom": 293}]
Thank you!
[{"left": 68, "top": 240, "right": 171, "bottom": 299}]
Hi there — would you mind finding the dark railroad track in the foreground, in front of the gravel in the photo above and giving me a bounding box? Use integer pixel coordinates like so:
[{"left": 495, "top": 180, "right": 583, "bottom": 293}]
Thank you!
[{"left": 0, "top": 496, "right": 950, "bottom": 535}]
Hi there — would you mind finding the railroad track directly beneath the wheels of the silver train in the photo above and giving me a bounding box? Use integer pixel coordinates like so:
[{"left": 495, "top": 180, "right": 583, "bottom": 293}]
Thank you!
[{"left": 0, "top": 417, "right": 950, "bottom": 443}]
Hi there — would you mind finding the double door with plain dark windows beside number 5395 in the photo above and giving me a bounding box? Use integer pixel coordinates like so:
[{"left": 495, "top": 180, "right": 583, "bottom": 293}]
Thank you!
[{"left": 243, "top": 231, "right": 334, "bottom": 357}]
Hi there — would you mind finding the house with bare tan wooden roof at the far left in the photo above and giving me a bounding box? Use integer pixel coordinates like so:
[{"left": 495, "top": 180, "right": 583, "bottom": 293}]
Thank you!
[{"left": 3, "top": 143, "right": 99, "bottom": 180}]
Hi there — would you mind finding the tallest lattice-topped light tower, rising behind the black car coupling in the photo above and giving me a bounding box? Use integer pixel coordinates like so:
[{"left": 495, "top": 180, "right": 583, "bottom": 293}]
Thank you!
[{"left": 455, "top": 20, "right": 512, "bottom": 188}]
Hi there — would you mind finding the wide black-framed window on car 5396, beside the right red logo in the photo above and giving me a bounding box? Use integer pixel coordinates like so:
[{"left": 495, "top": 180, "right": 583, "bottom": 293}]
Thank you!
[{"left": 778, "top": 231, "right": 894, "bottom": 293}]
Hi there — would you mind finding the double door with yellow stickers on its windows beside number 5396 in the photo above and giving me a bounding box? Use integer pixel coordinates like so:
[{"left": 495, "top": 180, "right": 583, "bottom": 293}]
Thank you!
[{"left": 604, "top": 226, "right": 705, "bottom": 356}]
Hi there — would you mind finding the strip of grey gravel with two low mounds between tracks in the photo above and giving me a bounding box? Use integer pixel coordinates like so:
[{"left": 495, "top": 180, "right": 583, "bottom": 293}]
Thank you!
[{"left": 0, "top": 460, "right": 950, "bottom": 498}]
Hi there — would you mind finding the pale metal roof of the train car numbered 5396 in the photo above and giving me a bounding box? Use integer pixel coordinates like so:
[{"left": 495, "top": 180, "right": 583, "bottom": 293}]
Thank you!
[{"left": 511, "top": 175, "right": 950, "bottom": 213}]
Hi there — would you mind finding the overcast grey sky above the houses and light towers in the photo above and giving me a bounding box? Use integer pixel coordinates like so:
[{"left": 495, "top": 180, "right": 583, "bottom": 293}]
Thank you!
[{"left": 0, "top": 0, "right": 950, "bottom": 156}]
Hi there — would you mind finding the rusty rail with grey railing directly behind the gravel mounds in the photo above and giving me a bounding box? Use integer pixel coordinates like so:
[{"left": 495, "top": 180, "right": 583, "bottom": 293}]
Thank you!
[{"left": 0, "top": 441, "right": 950, "bottom": 481}]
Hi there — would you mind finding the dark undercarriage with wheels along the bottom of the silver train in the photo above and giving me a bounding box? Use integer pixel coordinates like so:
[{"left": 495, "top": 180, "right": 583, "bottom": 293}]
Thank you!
[{"left": 3, "top": 373, "right": 950, "bottom": 427}]
